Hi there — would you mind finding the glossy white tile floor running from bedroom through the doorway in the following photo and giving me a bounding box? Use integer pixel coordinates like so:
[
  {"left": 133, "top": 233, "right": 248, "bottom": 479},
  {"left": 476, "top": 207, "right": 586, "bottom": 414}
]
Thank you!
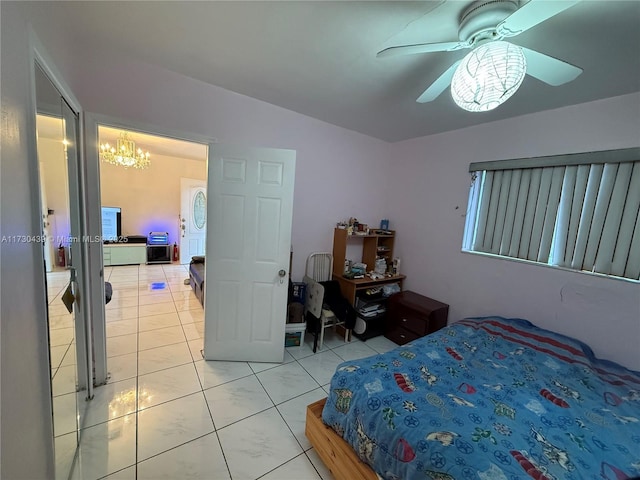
[{"left": 49, "top": 265, "right": 396, "bottom": 480}]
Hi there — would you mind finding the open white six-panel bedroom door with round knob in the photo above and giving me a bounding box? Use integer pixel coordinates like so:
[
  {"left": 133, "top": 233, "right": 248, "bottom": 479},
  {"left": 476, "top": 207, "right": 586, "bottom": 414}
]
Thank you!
[{"left": 204, "top": 144, "right": 296, "bottom": 362}]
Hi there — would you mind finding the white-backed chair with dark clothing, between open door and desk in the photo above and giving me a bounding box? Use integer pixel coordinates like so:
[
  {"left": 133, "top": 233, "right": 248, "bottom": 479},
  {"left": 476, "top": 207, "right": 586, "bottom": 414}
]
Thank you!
[{"left": 304, "top": 252, "right": 349, "bottom": 353}]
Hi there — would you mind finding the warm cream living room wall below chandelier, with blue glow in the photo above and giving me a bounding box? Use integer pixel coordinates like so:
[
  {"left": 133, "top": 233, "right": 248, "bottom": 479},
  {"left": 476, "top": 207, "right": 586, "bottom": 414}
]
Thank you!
[{"left": 100, "top": 154, "right": 207, "bottom": 244}]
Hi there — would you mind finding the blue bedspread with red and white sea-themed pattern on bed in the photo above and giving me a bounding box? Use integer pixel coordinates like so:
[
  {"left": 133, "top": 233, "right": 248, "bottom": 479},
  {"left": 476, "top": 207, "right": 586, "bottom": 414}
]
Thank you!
[{"left": 322, "top": 317, "right": 640, "bottom": 480}]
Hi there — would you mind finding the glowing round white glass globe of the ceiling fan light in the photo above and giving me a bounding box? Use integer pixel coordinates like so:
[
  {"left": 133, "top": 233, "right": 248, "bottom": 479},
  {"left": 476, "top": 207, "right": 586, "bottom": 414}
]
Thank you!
[{"left": 451, "top": 41, "right": 527, "bottom": 112}]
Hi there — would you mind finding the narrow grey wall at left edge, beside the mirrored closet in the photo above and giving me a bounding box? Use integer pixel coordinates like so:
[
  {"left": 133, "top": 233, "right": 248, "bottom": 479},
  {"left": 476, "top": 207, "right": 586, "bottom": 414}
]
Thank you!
[{"left": 0, "top": 2, "right": 54, "bottom": 479}]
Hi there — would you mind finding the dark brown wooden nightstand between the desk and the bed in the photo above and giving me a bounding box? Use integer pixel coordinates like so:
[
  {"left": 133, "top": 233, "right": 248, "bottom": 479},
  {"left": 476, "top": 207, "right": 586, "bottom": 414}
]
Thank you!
[{"left": 385, "top": 291, "right": 449, "bottom": 345}]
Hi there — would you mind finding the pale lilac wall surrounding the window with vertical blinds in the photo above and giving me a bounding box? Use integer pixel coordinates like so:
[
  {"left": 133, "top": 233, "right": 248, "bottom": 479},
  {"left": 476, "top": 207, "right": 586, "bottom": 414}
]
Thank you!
[{"left": 390, "top": 94, "right": 640, "bottom": 370}]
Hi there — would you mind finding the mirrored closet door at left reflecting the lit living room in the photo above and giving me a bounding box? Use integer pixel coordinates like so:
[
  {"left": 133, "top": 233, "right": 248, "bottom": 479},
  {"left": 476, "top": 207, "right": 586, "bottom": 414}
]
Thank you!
[{"left": 35, "top": 63, "right": 91, "bottom": 480}]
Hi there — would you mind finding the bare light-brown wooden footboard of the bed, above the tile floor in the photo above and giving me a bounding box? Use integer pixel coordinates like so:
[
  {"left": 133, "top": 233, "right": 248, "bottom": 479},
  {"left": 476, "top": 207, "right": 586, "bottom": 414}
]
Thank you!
[{"left": 304, "top": 398, "right": 379, "bottom": 480}]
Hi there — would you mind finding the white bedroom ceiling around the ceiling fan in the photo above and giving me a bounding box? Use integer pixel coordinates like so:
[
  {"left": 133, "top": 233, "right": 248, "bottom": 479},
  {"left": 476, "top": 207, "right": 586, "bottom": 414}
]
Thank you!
[{"left": 25, "top": 0, "right": 640, "bottom": 141}]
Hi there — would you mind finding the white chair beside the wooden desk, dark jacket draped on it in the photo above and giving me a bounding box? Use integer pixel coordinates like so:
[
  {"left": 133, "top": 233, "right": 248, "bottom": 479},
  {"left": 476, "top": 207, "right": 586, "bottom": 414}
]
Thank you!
[{"left": 304, "top": 252, "right": 348, "bottom": 351}]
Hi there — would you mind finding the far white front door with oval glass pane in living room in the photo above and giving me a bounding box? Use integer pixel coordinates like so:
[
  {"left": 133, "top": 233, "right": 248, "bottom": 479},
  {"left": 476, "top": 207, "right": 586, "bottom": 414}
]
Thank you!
[{"left": 180, "top": 178, "right": 207, "bottom": 264}]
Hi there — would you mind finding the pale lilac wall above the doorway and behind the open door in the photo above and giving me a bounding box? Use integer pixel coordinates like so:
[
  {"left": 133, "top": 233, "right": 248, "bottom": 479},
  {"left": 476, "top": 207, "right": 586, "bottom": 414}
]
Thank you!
[{"left": 61, "top": 50, "right": 391, "bottom": 281}]
